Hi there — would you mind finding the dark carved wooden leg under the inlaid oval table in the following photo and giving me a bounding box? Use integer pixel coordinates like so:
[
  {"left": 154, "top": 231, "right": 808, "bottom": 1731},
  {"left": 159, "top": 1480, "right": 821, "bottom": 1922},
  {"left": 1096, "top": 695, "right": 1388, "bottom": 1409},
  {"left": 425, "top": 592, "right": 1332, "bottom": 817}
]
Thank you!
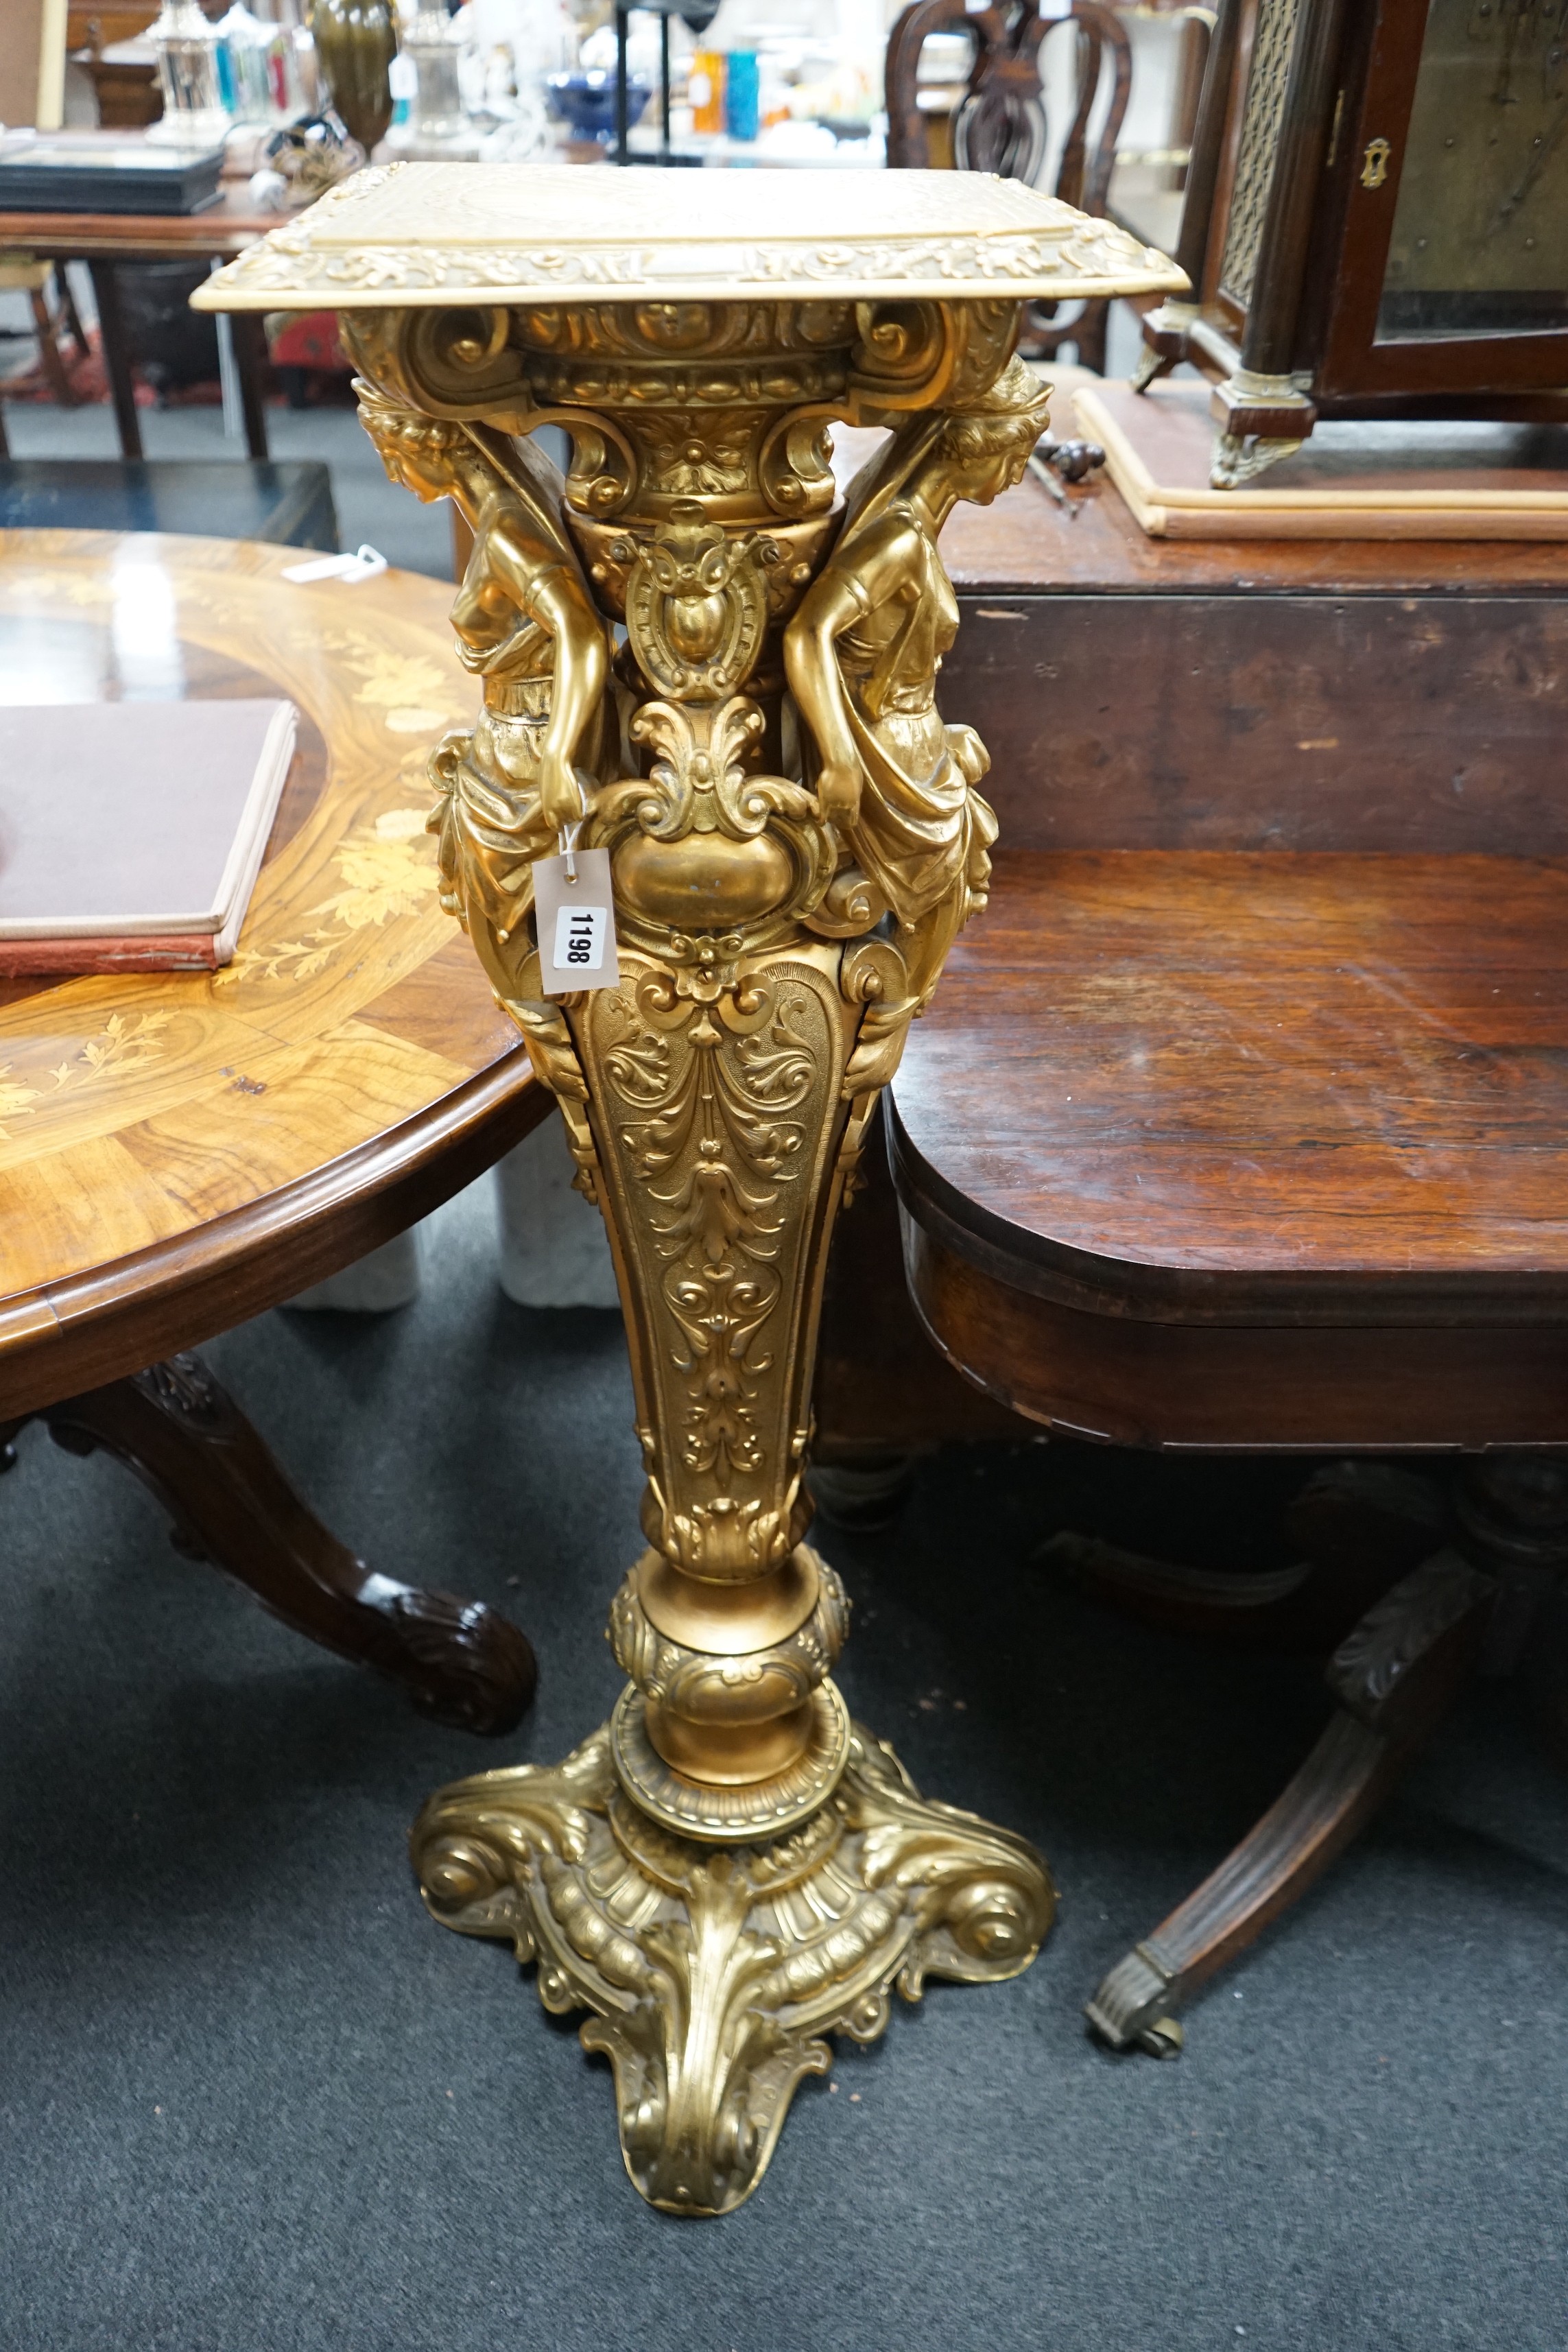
[{"left": 35, "top": 1355, "right": 536, "bottom": 1733}]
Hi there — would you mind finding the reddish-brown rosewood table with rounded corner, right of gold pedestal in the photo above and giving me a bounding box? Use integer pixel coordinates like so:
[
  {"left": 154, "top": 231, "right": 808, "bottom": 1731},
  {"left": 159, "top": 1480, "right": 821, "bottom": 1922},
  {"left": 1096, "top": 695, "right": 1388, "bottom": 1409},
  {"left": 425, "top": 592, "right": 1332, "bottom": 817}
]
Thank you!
[{"left": 888, "top": 463, "right": 1568, "bottom": 2051}]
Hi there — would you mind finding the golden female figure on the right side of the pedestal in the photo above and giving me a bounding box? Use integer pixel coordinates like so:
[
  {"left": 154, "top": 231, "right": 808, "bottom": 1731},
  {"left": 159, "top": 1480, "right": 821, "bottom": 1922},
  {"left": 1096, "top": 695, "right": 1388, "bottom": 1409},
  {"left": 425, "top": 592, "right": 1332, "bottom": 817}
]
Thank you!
[{"left": 785, "top": 360, "right": 1051, "bottom": 1004}]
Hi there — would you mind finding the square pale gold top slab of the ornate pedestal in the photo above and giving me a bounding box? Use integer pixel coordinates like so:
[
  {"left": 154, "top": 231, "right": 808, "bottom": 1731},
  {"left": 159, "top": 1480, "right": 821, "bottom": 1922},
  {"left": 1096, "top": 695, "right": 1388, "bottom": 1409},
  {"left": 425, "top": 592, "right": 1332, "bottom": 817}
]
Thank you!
[{"left": 193, "top": 163, "right": 1187, "bottom": 311}]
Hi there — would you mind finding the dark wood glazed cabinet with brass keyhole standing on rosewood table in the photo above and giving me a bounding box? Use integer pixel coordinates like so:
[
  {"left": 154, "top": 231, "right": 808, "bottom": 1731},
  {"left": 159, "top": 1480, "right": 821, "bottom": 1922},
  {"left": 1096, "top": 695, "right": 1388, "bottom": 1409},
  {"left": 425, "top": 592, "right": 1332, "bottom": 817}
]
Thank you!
[{"left": 1138, "top": 0, "right": 1568, "bottom": 489}]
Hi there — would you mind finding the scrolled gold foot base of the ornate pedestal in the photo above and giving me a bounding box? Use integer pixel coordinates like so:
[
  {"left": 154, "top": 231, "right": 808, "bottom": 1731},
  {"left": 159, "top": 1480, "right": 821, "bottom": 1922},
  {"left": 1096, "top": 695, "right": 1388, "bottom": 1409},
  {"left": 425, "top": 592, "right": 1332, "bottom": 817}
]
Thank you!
[{"left": 409, "top": 1724, "right": 1056, "bottom": 2213}]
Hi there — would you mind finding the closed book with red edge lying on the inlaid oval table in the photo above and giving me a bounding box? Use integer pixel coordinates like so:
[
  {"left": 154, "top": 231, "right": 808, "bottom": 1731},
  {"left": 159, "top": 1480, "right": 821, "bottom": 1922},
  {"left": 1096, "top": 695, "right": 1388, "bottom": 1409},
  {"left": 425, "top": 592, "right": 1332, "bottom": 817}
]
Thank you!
[{"left": 0, "top": 685, "right": 298, "bottom": 978}]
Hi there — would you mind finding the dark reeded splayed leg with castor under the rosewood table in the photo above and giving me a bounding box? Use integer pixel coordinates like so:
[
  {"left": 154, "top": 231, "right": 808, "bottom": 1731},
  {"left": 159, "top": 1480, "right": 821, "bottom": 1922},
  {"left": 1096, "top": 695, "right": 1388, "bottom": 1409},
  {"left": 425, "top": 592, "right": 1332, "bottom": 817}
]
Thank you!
[{"left": 1084, "top": 1552, "right": 1497, "bottom": 2058}]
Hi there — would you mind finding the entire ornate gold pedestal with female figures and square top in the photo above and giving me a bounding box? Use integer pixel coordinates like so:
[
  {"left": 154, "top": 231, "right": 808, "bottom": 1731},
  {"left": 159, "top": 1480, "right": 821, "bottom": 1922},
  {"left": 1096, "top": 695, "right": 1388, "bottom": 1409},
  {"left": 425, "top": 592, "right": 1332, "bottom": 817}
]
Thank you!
[{"left": 198, "top": 165, "right": 1180, "bottom": 2213}]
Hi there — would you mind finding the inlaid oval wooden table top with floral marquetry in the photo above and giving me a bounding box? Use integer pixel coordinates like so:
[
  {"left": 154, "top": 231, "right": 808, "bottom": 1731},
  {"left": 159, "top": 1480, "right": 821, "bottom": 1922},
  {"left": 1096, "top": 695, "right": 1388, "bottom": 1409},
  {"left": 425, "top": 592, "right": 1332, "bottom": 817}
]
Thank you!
[{"left": 0, "top": 532, "right": 548, "bottom": 1416}]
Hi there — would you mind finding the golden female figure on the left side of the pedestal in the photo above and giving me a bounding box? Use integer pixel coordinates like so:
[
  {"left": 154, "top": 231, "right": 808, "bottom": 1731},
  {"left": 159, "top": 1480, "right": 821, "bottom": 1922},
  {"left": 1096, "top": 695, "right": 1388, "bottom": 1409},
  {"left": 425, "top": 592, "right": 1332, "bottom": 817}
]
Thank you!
[{"left": 357, "top": 383, "right": 609, "bottom": 960}]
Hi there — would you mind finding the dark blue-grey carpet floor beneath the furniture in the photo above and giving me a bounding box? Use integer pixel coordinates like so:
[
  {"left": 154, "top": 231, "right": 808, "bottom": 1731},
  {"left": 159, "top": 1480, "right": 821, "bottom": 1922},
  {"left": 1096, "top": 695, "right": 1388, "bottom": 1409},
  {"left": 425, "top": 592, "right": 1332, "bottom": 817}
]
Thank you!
[{"left": 0, "top": 1197, "right": 1568, "bottom": 2352}]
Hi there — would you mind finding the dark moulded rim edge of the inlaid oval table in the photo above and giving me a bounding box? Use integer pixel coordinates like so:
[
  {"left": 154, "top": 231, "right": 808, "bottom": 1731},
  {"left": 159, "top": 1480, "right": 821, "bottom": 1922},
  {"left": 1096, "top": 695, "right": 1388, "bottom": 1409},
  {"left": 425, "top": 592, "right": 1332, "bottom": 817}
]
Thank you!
[{"left": 0, "top": 1042, "right": 552, "bottom": 1418}]
